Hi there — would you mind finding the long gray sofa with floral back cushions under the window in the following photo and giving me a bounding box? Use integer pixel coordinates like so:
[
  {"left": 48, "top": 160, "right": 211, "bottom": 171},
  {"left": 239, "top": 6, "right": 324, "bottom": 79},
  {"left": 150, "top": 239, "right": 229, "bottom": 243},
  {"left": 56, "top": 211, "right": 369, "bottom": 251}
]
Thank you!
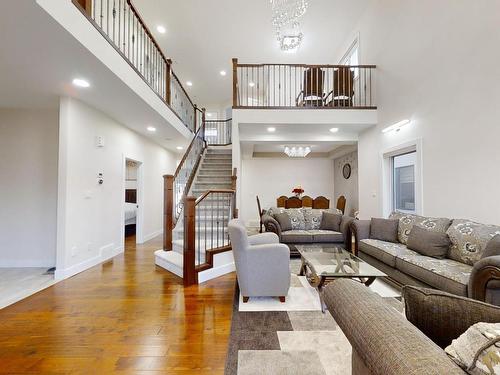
[{"left": 351, "top": 212, "right": 500, "bottom": 305}]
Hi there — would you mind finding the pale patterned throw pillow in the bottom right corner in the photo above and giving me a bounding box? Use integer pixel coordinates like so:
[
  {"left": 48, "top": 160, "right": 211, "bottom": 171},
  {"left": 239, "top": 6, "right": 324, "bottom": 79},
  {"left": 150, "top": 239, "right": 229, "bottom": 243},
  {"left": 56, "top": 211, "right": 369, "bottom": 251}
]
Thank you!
[{"left": 445, "top": 323, "right": 500, "bottom": 375}]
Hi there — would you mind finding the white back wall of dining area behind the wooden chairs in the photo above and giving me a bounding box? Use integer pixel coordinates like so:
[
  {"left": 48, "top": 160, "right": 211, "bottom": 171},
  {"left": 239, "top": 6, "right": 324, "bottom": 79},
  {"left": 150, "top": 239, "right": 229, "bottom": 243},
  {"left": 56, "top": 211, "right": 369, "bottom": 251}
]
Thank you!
[{"left": 239, "top": 158, "right": 335, "bottom": 226}]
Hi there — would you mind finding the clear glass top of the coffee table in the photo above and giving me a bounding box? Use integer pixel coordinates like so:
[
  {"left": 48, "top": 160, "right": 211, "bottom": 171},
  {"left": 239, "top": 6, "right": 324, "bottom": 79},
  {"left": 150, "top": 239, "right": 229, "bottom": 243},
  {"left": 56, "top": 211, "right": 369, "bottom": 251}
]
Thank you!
[{"left": 295, "top": 244, "right": 387, "bottom": 277}]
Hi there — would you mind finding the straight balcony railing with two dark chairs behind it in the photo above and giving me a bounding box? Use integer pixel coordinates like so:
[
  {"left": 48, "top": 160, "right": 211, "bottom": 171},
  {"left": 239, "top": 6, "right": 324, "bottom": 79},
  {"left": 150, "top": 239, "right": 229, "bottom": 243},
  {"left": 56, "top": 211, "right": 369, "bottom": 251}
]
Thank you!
[{"left": 233, "top": 59, "right": 377, "bottom": 109}]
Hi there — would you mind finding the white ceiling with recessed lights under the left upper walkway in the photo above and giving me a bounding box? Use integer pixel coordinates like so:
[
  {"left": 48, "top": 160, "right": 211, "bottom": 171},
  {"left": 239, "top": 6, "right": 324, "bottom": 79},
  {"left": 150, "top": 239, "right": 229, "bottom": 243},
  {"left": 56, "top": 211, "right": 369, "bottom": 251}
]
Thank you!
[{"left": 0, "top": 0, "right": 189, "bottom": 152}]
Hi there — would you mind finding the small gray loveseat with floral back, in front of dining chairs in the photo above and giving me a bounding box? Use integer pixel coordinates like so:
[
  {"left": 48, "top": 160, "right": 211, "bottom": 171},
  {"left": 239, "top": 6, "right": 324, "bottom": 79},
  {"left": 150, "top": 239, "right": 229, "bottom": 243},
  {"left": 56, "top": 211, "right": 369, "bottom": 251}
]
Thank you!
[{"left": 262, "top": 207, "right": 354, "bottom": 251}]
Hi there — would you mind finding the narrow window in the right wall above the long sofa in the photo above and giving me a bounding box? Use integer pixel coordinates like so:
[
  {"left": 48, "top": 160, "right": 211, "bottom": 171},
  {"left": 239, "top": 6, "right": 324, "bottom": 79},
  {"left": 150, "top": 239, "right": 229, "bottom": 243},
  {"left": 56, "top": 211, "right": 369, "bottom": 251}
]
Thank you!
[{"left": 391, "top": 151, "right": 417, "bottom": 213}]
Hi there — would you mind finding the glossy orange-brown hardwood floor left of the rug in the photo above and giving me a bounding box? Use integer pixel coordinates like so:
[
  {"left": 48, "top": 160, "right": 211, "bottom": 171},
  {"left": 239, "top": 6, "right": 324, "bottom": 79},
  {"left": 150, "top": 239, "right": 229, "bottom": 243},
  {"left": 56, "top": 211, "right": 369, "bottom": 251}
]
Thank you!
[{"left": 0, "top": 237, "right": 235, "bottom": 374}]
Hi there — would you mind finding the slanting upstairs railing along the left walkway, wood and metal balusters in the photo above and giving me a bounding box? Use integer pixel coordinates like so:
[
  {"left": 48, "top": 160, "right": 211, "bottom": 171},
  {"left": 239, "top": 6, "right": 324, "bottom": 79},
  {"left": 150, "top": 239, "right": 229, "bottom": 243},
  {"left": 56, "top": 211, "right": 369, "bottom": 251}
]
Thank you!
[{"left": 72, "top": 0, "right": 201, "bottom": 132}]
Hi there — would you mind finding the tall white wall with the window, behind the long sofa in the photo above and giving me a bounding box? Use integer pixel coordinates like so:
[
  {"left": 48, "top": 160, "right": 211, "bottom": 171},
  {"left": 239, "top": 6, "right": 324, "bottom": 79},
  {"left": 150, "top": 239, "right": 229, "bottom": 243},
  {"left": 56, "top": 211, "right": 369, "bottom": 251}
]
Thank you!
[{"left": 346, "top": 0, "right": 500, "bottom": 224}]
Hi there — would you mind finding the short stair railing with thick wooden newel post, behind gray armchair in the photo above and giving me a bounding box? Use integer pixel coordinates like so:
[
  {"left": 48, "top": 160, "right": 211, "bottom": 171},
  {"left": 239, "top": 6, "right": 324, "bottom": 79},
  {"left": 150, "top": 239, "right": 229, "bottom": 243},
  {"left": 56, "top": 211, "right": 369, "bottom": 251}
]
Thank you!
[{"left": 183, "top": 168, "right": 238, "bottom": 286}]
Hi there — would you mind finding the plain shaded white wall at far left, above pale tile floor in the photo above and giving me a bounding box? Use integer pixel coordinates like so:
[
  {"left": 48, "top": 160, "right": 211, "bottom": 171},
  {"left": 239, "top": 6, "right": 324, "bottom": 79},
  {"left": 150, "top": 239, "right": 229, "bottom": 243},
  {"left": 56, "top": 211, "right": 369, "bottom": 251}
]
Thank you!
[{"left": 0, "top": 109, "right": 58, "bottom": 268}]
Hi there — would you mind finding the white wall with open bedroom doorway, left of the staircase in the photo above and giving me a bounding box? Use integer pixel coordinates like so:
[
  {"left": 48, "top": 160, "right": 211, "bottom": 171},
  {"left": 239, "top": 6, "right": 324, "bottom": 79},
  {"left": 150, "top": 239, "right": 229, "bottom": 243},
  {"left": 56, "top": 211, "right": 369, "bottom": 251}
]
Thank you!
[{"left": 56, "top": 98, "right": 175, "bottom": 277}]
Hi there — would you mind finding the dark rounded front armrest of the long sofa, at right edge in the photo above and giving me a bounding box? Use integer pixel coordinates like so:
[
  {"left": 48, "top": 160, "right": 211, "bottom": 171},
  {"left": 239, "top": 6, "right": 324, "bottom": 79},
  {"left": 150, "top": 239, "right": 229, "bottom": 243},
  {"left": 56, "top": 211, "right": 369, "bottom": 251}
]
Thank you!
[{"left": 467, "top": 255, "right": 500, "bottom": 304}]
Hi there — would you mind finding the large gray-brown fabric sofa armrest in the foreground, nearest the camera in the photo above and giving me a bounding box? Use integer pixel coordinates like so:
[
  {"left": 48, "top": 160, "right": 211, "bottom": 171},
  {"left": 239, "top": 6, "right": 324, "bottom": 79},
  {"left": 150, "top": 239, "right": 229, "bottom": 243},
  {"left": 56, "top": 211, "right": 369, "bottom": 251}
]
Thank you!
[{"left": 324, "top": 279, "right": 463, "bottom": 375}]
